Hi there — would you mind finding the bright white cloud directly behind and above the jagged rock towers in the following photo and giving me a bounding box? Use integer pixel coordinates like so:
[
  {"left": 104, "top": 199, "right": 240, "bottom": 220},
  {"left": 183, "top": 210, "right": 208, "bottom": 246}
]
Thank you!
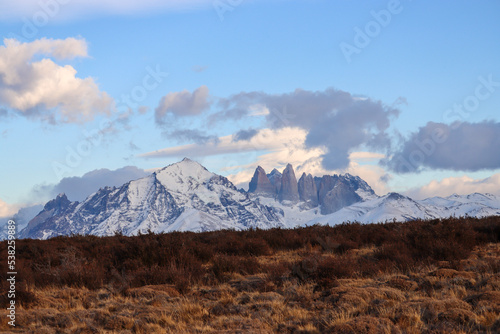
[{"left": 141, "top": 127, "right": 388, "bottom": 195}]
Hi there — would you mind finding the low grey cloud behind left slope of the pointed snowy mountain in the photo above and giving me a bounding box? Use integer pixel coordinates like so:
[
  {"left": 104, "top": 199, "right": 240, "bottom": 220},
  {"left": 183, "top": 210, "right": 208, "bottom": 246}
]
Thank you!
[{"left": 34, "top": 166, "right": 149, "bottom": 201}]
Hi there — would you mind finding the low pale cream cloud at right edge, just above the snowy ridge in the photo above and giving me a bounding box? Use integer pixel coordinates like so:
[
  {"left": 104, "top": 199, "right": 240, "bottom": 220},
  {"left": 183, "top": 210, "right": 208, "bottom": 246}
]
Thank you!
[{"left": 407, "top": 173, "right": 500, "bottom": 199}]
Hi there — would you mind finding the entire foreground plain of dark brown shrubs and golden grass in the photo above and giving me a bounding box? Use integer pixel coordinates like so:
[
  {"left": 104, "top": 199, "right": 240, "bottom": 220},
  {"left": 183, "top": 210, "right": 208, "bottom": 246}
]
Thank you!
[{"left": 0, "top": 217, "right": 500, "bottom": 333}]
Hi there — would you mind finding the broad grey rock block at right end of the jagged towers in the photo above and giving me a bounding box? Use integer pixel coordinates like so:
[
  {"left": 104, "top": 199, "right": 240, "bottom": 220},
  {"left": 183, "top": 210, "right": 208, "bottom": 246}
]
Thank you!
[{"left": 318, "top": 175, "right": 362, "bottom": 215}]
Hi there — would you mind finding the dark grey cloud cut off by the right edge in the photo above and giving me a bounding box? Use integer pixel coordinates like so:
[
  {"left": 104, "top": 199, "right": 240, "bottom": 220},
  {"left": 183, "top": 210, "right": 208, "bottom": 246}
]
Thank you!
[{"left": 381, "top": 121, "right": 500, "bottom": 173}]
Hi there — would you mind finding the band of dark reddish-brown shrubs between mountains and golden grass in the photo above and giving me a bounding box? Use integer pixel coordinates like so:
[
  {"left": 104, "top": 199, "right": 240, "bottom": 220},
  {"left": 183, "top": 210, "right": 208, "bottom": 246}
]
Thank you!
[{"left": 0, "top": 217, "right": 500, "bottom": 294}]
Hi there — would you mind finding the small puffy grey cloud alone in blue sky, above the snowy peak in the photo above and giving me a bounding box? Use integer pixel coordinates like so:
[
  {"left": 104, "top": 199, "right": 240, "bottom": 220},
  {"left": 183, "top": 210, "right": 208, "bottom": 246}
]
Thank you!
[{"left": 155, "top": 86, "right": 211, "bottom": 124}]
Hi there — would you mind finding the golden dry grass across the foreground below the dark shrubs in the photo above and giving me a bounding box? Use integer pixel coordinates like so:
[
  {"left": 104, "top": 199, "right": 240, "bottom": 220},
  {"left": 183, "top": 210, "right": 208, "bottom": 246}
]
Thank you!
[{"left": 4, "top": 244, "right": 500, "bottom": 334}]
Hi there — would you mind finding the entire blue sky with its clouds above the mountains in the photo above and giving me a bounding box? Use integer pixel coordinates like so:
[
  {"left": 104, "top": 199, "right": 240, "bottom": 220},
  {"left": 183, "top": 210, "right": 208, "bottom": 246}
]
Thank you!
[{"left": 0, "top": 0, "right": 500, "bottom": 215}]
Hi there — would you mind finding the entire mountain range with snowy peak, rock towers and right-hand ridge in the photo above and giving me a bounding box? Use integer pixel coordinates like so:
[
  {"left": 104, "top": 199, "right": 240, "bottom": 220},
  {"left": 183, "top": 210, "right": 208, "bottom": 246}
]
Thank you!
[{"left": 3, "top": 158, "right": 500, "bottom": 239}]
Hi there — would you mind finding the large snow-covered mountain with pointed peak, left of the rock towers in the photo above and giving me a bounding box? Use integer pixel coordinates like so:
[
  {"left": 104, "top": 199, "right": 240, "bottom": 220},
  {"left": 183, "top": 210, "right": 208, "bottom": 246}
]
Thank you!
[{"left": 20, "top": 159, "right": 283, "bottom": 239}]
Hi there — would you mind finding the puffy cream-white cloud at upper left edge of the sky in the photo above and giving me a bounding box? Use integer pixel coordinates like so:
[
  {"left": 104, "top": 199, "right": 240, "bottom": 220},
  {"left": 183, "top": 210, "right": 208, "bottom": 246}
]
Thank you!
[{"left": 0, "top": 38, "right": 113, "bottom": 123}]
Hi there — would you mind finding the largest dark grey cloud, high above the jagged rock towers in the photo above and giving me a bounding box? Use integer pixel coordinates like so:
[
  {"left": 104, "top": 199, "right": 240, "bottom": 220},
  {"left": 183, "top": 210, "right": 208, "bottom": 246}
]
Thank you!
[{"left": 211, "top": 88, "right": 399, "bottom": 169}]
